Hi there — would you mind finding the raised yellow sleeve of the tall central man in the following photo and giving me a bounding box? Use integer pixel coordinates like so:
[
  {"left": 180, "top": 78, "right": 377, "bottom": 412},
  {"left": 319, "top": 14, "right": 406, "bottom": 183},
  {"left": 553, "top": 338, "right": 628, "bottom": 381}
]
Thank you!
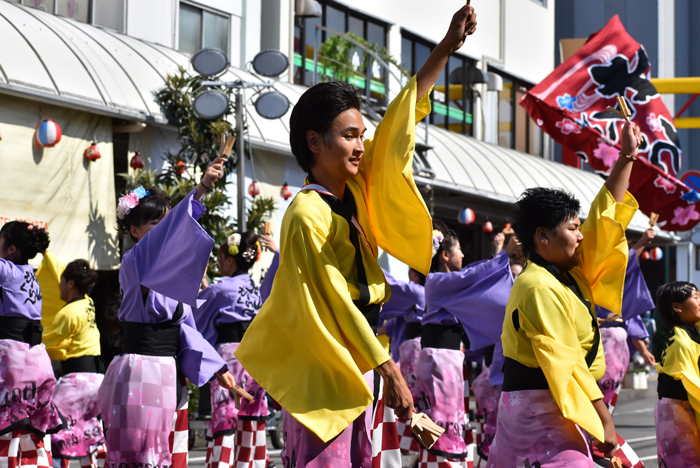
[{"left": 358, "top": 76, "right": 433, "bottom": 274}]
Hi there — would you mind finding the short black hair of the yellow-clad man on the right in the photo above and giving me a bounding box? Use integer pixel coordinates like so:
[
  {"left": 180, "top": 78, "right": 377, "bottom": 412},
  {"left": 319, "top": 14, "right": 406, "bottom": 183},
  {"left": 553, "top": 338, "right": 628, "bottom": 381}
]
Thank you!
[{"left": 513, "top": 187, "right": 581, "bottom": 256}]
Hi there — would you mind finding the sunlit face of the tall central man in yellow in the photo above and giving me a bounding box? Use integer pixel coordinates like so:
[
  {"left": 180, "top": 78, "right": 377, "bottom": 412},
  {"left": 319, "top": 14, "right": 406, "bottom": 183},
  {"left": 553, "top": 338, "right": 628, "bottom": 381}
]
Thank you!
[{"left": 309, "top": 109, "right": 367, "bottom": 181}]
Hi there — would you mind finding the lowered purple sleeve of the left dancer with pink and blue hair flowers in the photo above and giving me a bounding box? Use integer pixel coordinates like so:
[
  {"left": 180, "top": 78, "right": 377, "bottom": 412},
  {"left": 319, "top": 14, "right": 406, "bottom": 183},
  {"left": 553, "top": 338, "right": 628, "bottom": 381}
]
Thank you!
[{"left": 177, "top": 308, "right": 228, "bottom": 387}]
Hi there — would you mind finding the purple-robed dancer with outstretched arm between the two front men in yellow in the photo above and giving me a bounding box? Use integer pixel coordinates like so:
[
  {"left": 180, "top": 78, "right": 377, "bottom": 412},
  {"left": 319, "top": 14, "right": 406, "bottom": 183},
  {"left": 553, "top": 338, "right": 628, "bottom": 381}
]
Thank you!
[{"left": 415, "top": 225, "right": 517, "bottom": 467}]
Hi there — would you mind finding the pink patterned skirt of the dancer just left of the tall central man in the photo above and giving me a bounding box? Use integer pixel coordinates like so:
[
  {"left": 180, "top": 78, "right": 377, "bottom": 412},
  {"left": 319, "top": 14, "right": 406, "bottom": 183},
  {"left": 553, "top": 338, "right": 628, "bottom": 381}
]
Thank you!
[{"left": 208, "top": 343, "right": 269, "bottom": 438}]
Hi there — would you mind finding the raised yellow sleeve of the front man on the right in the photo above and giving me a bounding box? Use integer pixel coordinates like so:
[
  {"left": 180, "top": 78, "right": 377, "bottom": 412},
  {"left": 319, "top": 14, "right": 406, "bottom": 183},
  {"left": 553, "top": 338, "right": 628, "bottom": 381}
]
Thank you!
[{"left": 577, "top": 185, "right": 639, "bottom": 314}]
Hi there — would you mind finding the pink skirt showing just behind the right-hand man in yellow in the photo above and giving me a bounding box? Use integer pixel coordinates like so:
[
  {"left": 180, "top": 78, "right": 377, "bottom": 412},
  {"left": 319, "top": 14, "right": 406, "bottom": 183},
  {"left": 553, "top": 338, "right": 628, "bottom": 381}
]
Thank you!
[{"left": 598, "top": 327, "right": 630, "bottom": 405}]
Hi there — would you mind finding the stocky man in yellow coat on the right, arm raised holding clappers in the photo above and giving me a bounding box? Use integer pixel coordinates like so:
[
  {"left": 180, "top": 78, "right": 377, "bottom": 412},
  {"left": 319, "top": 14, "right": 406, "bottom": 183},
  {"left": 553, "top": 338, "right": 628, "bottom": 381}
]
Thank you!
[{"left": 487, "top": 123, "right": 641, "bottom": 468}]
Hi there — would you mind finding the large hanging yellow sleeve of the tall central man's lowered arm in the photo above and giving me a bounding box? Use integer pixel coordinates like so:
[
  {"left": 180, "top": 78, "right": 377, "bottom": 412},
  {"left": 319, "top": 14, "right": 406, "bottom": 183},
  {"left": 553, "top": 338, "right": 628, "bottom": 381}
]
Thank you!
[{"left": 235, "top": 200, "right": 389, "bottom": 441}]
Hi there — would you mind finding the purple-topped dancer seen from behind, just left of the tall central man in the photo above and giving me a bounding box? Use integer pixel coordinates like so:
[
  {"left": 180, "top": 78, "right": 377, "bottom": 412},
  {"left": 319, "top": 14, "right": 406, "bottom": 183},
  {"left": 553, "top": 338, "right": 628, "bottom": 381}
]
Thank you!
[{"left": 194, "top": 232, "right": 268, "bottom": 468}]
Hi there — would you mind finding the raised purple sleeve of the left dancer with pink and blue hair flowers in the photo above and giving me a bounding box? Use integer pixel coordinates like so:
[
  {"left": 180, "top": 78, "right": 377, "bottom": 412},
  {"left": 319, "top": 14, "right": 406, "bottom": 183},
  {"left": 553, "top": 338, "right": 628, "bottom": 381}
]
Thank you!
[{"left": 132, "top": 190, "right": 214, "bottom": 307}]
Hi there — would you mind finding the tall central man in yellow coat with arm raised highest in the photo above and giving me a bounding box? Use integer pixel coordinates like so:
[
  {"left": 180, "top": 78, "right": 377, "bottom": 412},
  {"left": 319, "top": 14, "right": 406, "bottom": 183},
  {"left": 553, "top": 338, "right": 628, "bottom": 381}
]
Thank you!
[{"left": 236, "top": 6, "right": 476, "bottom": 466}]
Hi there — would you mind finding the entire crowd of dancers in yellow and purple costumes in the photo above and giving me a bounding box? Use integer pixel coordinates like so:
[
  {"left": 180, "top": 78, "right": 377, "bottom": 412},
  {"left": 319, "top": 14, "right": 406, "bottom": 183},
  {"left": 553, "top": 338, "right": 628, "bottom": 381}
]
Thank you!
[{"left": 0, "top": 1, "right": 700, "bottom": 468}]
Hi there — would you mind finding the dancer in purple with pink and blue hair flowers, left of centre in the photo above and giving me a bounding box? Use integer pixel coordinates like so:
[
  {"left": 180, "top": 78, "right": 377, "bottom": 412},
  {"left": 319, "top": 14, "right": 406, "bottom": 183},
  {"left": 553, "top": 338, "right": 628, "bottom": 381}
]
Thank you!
[{"left": 99, "top": 158, "right": 234, "bottom": 467}]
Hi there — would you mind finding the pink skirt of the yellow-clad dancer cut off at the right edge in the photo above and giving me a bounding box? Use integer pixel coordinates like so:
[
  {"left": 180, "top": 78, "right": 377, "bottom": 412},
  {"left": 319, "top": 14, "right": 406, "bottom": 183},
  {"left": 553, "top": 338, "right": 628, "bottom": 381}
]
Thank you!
[{"left": 654, "top": 398, "right": 700, "bottom": 468}]
